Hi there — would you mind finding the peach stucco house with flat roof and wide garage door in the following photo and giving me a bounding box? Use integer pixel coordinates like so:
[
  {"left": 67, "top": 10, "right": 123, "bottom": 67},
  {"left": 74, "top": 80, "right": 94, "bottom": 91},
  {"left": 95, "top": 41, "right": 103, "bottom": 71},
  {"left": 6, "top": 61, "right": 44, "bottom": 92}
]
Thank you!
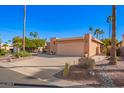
[{"left": 49, "top": 34, "right": 103, "bottom": 56}]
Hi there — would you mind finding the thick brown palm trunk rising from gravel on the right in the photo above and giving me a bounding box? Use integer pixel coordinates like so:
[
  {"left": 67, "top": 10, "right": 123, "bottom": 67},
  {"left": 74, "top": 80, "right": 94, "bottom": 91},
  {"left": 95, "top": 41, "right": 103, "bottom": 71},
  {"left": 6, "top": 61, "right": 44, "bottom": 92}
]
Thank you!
[{"left": 109, "top": 5, "right": 117, "bottom": 65}]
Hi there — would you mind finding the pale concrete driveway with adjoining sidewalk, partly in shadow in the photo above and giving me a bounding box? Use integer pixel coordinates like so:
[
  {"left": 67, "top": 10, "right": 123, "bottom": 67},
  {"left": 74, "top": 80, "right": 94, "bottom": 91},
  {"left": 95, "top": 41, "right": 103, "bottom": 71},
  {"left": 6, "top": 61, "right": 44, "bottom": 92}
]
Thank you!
[{"left": 0, "top": 54, "right": 82, "bottom": 87}]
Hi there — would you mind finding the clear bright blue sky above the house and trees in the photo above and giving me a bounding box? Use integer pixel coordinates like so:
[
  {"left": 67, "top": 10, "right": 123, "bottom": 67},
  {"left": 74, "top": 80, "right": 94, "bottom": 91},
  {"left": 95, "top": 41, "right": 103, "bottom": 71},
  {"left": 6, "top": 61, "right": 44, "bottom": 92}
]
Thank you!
[{"left": 0, "top": 5, "right": 124, "bottom": 42}]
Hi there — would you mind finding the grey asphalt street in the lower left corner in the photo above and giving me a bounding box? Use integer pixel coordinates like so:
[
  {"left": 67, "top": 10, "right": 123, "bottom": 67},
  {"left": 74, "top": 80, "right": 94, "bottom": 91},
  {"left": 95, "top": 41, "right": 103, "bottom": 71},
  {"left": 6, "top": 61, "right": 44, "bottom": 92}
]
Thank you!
[{"left": 0, "top": 67, "right": 59, "bottom": 88}]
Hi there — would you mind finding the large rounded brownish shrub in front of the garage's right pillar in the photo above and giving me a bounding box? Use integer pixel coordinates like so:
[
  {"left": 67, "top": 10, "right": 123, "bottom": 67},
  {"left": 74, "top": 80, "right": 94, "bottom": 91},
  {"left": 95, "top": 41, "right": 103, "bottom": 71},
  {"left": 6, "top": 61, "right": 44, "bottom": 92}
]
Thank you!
[{"left": 78, "top": 57, "right": 95, "bottom": 69}]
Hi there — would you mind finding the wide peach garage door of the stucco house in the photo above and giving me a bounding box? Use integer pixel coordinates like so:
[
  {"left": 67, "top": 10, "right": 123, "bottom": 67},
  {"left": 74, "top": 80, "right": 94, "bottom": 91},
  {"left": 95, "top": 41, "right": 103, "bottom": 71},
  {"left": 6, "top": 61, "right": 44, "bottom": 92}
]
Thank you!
[{"left": 56, "top": 41, "right": 84, "bottom": 56}]
